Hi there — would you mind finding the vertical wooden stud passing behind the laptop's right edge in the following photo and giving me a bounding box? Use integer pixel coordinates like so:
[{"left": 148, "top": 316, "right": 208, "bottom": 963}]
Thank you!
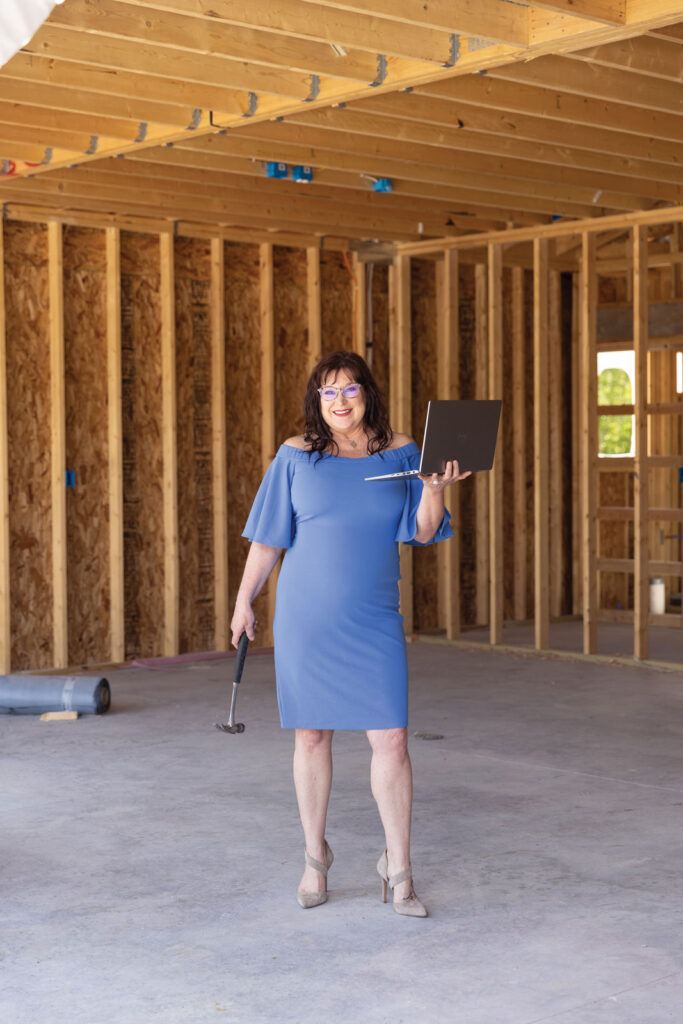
[{"left": 488, "top": 244, "right": 505, "bottom": 644}]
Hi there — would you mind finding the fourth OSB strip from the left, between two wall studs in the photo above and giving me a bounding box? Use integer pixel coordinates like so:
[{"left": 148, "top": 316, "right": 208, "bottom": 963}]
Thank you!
[{"left": 174, "top": 239, "right": 215, "bottom": 652}]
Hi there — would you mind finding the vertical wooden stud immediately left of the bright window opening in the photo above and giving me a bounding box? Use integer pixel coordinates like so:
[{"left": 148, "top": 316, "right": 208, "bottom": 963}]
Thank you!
[{"left": 581, "top": 231, "right": 598, "bottom": 654}]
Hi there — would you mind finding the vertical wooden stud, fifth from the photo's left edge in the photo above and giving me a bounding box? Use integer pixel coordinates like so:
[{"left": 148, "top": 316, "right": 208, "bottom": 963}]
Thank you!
[{"left": 210, "top": 239, "right": 230, "bottom": 650}]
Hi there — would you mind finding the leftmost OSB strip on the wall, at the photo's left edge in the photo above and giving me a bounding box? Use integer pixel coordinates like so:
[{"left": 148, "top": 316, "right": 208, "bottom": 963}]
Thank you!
[{"left": 4, "top": 221, "right": 53, "bottom": 670}]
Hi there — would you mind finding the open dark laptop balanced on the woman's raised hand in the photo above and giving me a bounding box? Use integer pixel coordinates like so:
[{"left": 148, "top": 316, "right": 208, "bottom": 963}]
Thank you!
[{"left": 366, "top": 398, "right": 501, "bottom": 480}]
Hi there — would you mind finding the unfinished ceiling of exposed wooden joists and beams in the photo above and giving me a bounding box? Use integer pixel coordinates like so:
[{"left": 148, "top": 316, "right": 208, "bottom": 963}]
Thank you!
[{"left": 0, "top": 0, "right": 683, "bottom": 242}]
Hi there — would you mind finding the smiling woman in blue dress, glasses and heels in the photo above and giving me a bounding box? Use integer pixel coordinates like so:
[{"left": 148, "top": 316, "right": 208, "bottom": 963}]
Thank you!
[{"left": 231, "top": 351, "right": 469, "bottom": 918}]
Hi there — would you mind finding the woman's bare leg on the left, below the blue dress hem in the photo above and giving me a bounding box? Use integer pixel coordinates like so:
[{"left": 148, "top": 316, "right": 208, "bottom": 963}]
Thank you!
[{"left": 294, "top": 729, "right": 334, "bottom": 893}]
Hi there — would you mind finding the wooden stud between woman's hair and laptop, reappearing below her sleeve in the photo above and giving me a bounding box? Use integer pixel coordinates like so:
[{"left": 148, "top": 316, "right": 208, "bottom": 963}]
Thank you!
[{"left": 389, "top": 256, "right": 413, "bottom": 637}]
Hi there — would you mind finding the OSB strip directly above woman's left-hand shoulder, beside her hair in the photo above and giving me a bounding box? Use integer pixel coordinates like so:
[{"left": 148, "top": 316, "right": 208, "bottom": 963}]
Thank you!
[{"left": 272, "top": 246, "right": 308, "bottom": 446}]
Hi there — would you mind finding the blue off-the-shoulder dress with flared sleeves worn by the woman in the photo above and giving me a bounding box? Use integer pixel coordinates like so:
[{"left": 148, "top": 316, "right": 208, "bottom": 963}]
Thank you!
[{"left": 243, "top": 441, "right": 453, "bottom": 729}]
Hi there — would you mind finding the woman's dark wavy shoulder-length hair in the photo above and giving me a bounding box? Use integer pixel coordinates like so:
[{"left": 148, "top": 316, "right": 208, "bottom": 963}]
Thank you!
[{"left": 303, "top": 350, "right": 393, "bottom": 461}]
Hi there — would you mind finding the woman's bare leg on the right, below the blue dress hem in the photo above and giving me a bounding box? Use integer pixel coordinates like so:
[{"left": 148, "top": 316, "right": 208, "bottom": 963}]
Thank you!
[{"left": 368, "top": 729, "right": 413, "bottom": 900}]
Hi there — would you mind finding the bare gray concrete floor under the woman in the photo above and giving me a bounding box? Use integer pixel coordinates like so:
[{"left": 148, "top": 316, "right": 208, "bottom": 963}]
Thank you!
[{"left": 0, "top": 643, "right": 683, "bottom": 1024}]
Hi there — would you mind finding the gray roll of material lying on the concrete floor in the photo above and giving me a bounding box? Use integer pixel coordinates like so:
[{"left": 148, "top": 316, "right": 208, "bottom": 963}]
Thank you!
[{"left": 0, "top": 676, "right": 112, "bottom": 715}]
